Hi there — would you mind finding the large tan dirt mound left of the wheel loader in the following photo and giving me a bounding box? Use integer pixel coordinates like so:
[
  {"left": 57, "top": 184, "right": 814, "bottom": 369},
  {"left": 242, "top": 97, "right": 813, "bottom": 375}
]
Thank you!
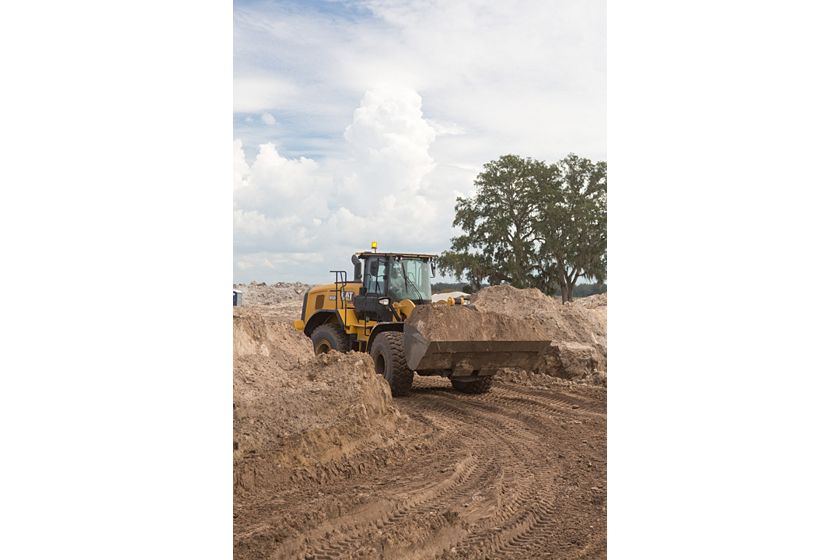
[{"left": 233, "top": 308, "right": 403, "bottom": 492}]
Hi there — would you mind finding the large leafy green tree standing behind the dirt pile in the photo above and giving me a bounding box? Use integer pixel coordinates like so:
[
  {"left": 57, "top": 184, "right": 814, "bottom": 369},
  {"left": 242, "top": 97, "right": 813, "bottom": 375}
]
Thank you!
[{"left": 438, "top": 154, "right": 607, "bottom": 301}]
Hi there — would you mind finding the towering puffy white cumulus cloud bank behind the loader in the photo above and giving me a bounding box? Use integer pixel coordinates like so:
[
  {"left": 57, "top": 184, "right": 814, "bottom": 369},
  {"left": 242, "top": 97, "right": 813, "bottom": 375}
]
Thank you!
[{"left": 234, "top": 85, "right": 460, "bottom": 280}]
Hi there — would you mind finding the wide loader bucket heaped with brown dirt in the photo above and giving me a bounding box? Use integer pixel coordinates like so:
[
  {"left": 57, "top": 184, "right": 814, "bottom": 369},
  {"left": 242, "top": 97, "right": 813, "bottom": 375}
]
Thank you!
[{"left": 403, "top": 305, "right": 551, "bottom": 375}]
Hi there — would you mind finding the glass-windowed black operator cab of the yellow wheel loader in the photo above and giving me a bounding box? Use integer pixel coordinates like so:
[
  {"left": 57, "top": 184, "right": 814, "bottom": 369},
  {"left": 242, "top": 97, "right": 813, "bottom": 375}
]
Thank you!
[{"left": 352, "top": 252, "right": 434, "bottom": 322}]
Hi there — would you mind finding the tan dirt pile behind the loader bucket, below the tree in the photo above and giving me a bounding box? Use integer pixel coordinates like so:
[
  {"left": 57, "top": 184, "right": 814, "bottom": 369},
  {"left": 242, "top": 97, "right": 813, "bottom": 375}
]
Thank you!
[{"left": 472, "top": 286, "right": 607, "bottom": 383}]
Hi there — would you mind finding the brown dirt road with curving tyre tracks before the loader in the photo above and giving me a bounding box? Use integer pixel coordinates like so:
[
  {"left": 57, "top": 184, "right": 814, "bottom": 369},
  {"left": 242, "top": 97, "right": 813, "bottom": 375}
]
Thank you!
[{"left": 234, "top": 375, "right": 607, "bottom": 559}]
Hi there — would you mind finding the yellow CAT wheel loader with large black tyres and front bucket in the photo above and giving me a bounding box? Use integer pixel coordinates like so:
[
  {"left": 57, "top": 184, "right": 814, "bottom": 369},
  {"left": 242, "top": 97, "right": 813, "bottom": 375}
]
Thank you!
[{"left": 294, "top": 252, "right": 550, "bottom": 396}]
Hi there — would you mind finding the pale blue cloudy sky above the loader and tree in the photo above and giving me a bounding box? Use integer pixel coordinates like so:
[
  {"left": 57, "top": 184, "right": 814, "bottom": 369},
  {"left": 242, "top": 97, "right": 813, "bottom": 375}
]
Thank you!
[{"left": 233, "top": 0, "right": 606, "bottom": 282}]
